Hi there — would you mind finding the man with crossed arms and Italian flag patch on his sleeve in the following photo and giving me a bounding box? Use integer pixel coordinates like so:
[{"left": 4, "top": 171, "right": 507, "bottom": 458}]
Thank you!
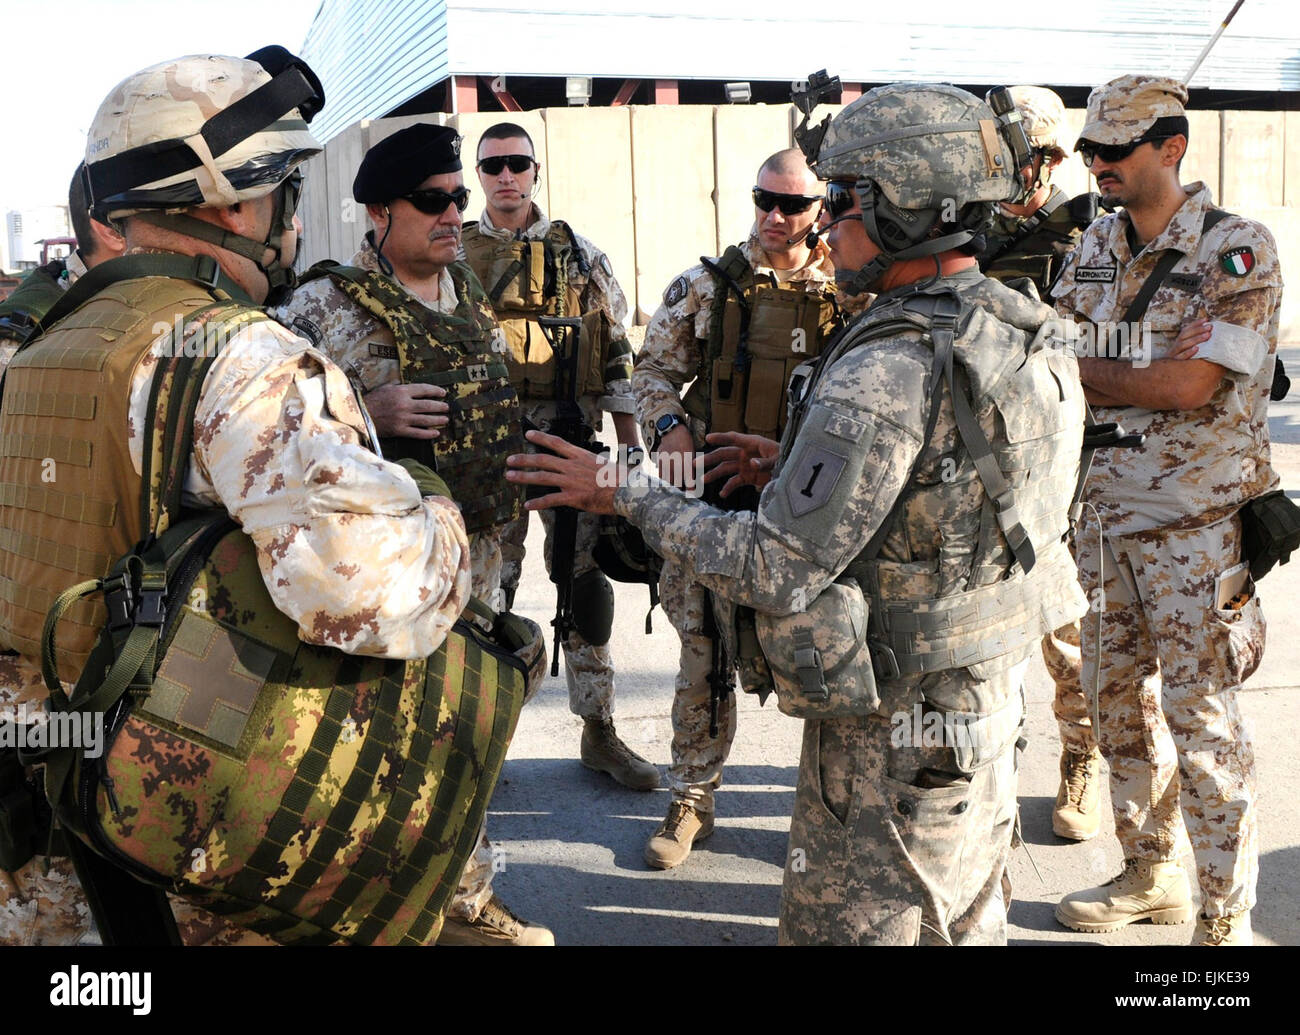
[{"left": 1053, "top": 75, "right": 1282, "bottom": 945}]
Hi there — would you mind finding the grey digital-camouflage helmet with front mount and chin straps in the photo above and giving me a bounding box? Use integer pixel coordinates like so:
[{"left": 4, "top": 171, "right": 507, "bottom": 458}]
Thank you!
[{"left": 796, "top": 77, "right": 1031, "bottom": 294}]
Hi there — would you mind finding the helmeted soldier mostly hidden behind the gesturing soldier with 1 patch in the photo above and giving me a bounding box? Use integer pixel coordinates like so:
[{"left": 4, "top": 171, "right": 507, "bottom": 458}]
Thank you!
[{"left": 979, "top": 86, "right": 1101, "bottom": 841}]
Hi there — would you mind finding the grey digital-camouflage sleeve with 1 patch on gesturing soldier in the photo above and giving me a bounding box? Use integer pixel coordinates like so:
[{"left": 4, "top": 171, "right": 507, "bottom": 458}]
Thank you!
[{"left": 615, "top": 350, "right": 928, "bottom": 615}]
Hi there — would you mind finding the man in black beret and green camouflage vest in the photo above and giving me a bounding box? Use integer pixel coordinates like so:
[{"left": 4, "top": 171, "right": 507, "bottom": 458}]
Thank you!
[{"left": 280, "top": 124, "right": 554, "bottom": 944}]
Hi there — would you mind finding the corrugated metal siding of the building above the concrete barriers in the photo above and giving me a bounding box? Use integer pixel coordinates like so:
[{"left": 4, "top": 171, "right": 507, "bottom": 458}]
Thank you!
[{"left": 304, "top": 0, "right": 1300, "bottom": 139}]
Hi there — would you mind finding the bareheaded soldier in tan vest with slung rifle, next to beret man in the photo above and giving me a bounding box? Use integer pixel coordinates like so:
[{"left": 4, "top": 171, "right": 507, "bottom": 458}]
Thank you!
[{"left": 462, "top": 122, "right": 659, "bottom": 791}]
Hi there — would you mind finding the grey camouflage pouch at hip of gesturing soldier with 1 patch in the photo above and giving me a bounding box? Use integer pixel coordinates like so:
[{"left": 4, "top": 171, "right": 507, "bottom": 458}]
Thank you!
[{"left": 755, "top": 583, "right": 880, "bottom": 719}]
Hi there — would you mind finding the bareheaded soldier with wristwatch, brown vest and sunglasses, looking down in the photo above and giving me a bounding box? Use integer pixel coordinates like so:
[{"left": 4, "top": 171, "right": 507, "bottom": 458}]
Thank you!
[{"left": 632, "top": 150, "right": 835, "bottom": 869}]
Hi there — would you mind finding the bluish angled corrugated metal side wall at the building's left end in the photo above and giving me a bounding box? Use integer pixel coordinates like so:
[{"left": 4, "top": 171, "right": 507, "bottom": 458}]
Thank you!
[{"left": 303, "top": 0, "right": 447, "bottom": 140}]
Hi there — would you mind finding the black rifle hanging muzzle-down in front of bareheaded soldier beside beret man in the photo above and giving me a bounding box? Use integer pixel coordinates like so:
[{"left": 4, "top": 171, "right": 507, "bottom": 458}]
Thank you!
[{"left": 537, "top": 316, "right": 605, "bottom": 676}]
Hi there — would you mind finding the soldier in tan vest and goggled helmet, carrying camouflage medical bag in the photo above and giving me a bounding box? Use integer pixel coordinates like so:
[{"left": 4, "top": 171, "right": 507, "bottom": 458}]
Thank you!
[{"left": 0, "top": 48, "right": 488, "bottom": 941}]
